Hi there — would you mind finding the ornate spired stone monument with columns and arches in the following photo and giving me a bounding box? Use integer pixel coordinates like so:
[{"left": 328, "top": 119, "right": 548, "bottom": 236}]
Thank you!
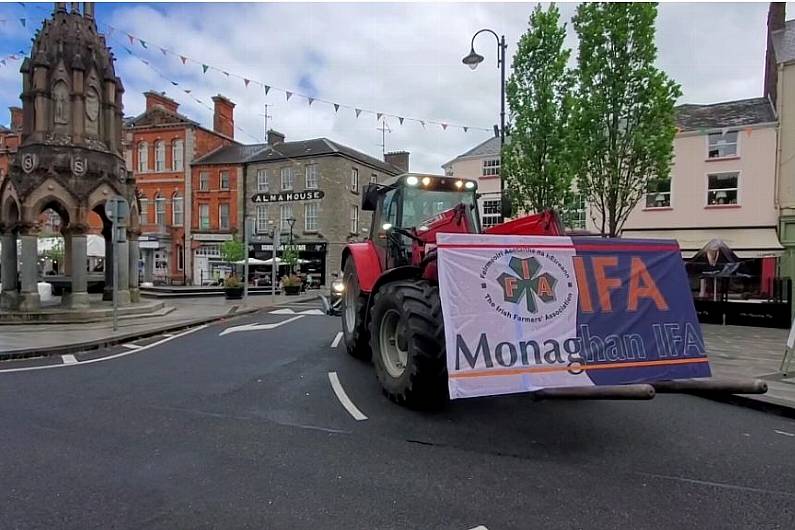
[{"left": 0, "top": 2, "right": 139, "bottom": 312}]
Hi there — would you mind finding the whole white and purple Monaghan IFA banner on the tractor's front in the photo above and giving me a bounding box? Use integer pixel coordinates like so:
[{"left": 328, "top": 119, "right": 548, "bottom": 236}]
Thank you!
[{"left": 437, "top": 234, "right": 710, "bottom": 399}]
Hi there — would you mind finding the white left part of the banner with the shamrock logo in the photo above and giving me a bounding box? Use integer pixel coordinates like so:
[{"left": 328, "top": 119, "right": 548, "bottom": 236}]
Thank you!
[{"left": 437, "top": 234, "right": 594, "bottom": 399}]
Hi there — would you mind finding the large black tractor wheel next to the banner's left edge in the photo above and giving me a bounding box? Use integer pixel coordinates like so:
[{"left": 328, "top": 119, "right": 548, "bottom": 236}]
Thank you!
[{"left": 370, "top": 280, "right": 448, "bottom": 409}]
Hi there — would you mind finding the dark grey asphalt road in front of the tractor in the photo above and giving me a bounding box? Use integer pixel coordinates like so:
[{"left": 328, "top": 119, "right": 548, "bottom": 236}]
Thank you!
[{"left": 0, "top": 305, "right": 795, "bottom": 530}]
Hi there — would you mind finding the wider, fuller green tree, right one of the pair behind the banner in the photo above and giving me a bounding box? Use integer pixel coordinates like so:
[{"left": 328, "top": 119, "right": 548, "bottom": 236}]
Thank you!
[{"left": 573, "top": 2, "right": 681, "bottom": 237}]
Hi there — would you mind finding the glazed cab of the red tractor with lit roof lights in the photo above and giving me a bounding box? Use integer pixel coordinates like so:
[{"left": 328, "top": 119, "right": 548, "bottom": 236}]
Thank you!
[{"left": 362, "top": 173, "right": 480, "bottom": 270}]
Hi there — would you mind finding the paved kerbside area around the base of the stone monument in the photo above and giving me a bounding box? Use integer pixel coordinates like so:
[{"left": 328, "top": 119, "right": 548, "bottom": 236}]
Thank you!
[{"left": 0, "top": 291, "right": 321, "bottom": 359}]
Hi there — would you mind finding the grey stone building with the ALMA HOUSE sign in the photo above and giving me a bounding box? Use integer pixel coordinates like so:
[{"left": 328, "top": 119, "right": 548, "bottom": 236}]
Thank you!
[{"left": 243, "top": 131, "right": 409, "bottom": 284}]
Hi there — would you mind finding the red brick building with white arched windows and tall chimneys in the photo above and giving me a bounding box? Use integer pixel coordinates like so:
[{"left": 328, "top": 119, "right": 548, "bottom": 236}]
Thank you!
[{"left": 125, "top": 91, "right": 236, "bottom": 284}]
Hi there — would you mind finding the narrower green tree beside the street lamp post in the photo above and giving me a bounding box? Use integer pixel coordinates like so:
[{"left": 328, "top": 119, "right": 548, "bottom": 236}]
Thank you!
[{"left": 501, "top": 4, "right": 573, "bottom": 212}]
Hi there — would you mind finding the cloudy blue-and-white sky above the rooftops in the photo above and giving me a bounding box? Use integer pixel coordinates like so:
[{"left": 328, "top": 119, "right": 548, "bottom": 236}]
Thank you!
[{"left": 0, "top": 3, "right": 795, "bottom": 173}]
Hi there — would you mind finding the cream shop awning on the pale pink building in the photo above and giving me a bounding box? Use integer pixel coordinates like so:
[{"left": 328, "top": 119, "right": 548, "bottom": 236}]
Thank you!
[{"left": 621, "top": 227, "right": 784, "bottom": 259}]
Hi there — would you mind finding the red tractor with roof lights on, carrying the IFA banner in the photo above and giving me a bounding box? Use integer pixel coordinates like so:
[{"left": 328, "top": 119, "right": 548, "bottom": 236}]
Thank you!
[{"left": 334, "top": 174, "right": 767, "bottom": 408}]
